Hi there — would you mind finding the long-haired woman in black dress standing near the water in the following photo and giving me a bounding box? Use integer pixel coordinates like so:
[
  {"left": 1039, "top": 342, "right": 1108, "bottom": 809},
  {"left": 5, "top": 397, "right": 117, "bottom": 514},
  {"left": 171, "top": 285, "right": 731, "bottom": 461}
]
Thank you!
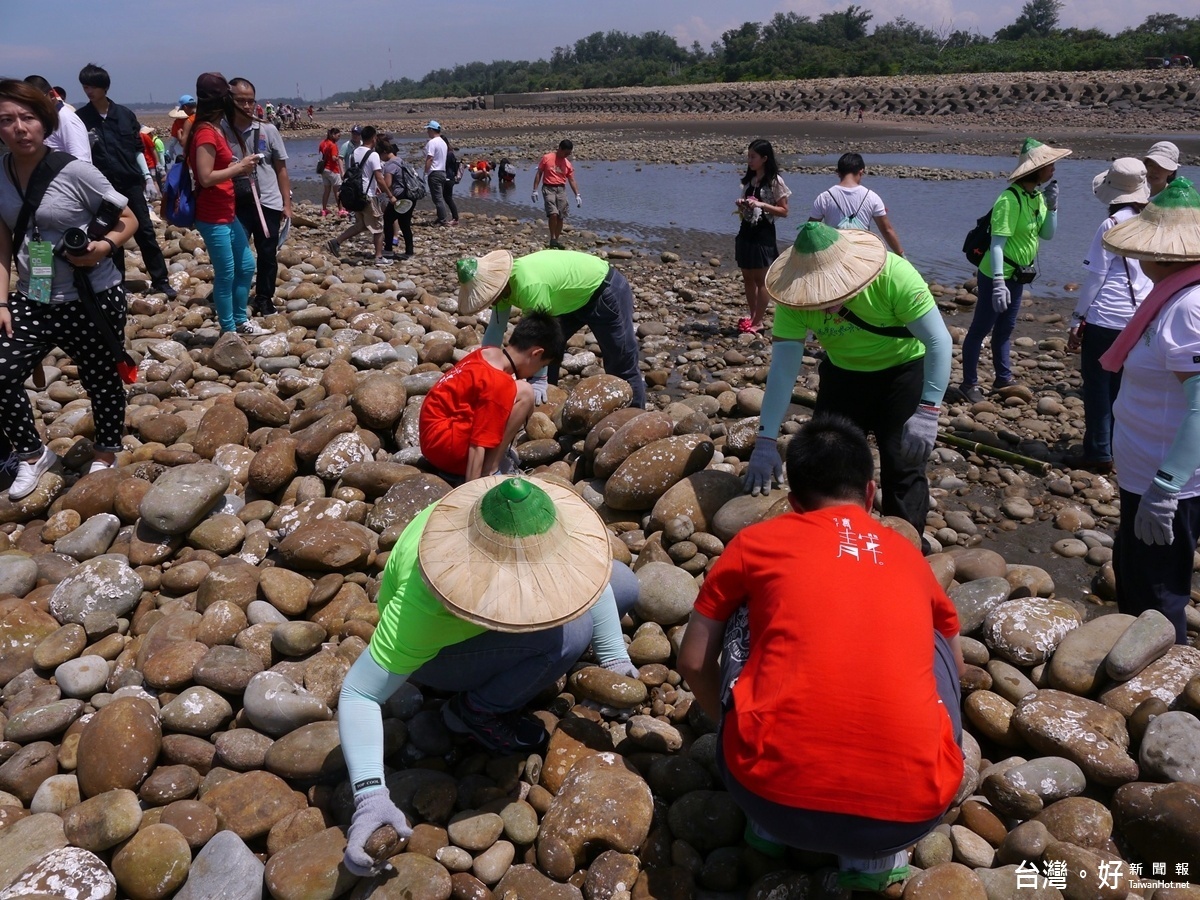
[{"left": 733, "top": 138, "right": 792, "bottom": 334}]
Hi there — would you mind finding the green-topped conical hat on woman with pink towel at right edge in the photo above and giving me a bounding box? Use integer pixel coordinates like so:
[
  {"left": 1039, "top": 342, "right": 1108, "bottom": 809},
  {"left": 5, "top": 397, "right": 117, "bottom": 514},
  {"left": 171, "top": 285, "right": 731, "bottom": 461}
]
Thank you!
[{"left": 1104, "top": 178, "right": 1200, "bottom": 263}]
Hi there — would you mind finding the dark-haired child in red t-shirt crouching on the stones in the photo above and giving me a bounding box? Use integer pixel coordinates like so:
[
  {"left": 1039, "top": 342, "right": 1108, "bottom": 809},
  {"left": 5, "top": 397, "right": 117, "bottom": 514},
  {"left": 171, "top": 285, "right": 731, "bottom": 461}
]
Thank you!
[{"left": 420, "top": 312, "right": 566, "bottom": 484}]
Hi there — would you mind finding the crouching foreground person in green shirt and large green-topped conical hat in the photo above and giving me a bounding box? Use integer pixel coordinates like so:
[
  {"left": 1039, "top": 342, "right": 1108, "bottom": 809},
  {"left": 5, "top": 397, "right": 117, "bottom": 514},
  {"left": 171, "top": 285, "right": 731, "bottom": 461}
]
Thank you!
[{"left": 337, "top": 475, "right": 638, "bottom": 875}]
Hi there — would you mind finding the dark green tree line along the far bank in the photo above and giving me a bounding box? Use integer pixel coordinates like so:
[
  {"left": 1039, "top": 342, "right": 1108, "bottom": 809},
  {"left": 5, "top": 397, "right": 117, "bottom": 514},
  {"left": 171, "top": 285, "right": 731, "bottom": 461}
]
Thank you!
[{"left": 329, "top": 6, "right": 1200, "bottom": 102}]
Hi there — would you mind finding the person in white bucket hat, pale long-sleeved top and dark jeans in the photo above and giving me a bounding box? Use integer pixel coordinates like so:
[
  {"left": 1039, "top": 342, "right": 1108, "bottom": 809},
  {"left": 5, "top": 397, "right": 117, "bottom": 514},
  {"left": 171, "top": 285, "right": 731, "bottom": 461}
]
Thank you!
[{"left": 1067, "top": 157, "right": 1152, "bottom": 474}]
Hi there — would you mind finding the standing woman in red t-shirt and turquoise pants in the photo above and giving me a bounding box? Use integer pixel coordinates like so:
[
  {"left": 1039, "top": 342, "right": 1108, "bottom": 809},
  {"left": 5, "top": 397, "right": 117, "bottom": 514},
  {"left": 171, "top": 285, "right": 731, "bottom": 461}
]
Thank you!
[{"left": 186, "top": 72, "right": 271, "bottom": 337}]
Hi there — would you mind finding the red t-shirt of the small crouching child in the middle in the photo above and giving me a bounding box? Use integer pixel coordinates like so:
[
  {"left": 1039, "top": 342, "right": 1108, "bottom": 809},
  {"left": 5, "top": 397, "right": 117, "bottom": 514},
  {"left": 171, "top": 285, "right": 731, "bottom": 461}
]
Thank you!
[{"left": 420, "top": 350, "right": 517, "bottom": 475}]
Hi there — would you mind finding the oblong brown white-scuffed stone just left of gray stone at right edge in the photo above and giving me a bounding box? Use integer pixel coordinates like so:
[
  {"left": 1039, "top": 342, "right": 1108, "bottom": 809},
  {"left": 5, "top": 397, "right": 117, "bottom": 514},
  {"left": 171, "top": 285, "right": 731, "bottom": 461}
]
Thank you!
[{"left": 1013, "top": 689, "right": 1138, "bottom": 786}]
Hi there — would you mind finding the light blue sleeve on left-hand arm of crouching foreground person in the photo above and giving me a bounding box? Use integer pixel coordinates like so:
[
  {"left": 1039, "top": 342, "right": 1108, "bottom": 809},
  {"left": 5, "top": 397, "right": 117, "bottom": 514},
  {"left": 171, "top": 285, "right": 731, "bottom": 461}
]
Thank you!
[{"left": 337, "top": 649, "right": 408, "bottom": 794}]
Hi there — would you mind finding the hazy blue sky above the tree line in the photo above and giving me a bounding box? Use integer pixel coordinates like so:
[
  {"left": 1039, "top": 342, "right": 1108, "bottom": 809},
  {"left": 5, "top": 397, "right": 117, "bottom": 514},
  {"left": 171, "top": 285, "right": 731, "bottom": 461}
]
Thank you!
[{"left": 0, "top": 0, "right": 1180, "bottom": 103}]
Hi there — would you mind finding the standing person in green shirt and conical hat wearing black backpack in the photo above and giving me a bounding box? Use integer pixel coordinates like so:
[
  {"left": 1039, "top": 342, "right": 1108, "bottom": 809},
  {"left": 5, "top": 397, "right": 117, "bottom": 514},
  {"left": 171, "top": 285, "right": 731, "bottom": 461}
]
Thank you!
[{"left": 959, "top": 138, "right": 1070, "bottom": 403}]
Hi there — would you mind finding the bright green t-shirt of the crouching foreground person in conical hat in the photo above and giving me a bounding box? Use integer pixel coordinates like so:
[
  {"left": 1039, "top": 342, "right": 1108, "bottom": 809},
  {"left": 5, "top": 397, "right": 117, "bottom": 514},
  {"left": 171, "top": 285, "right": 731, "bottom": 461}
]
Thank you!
[{"left": 370, "top": 504, "right": 487, "bottom": 674}]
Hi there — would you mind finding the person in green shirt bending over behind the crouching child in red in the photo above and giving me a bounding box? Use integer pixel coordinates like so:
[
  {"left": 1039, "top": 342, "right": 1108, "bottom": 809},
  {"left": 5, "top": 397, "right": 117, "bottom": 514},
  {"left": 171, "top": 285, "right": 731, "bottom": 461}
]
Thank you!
[{"left": 457, "top": 250, "right": 646, "bottom": 408}]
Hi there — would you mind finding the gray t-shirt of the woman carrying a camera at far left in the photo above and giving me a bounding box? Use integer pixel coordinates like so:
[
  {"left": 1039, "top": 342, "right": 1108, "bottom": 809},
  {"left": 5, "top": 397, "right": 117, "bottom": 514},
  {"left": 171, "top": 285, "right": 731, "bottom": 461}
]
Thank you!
[{"left": 0, "top": 160, "right": 128, "bottom": 304}]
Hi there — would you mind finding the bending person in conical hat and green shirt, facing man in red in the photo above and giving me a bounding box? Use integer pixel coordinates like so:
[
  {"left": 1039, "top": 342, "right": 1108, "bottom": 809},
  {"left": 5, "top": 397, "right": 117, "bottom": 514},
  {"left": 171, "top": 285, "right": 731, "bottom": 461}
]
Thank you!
[{"left": 745, "top": 222, "right": 950, "bottom": 542}]
